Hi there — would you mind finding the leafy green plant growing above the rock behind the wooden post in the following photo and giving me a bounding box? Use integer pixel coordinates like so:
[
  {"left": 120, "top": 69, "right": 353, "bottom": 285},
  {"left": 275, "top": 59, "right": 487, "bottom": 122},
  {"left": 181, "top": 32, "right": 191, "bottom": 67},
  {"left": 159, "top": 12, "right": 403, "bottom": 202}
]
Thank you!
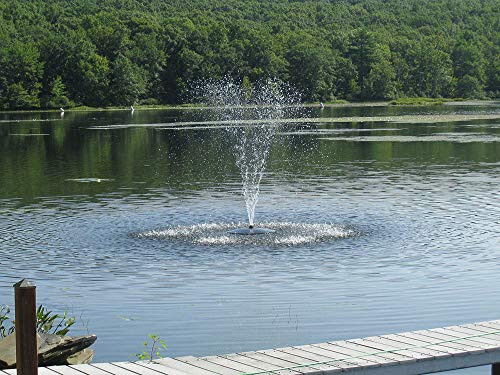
[{"left": 0, "top": 305, "right": 75, "bottom": 338}]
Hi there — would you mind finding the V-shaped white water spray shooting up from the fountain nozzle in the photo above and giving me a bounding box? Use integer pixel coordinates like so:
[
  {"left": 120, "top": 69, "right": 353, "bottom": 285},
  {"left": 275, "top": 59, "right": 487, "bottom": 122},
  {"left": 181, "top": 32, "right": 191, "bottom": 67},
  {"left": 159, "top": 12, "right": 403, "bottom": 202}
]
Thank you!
[{"left": 196, "top": 78, "right": 298, "bottom": 234}]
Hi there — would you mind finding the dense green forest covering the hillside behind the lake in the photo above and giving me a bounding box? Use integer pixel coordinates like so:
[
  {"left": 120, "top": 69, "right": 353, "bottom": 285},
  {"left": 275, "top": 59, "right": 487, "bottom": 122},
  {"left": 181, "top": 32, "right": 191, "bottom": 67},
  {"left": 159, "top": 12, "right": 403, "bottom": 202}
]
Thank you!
[{"left": 0, "top": 0, "right": 500, "bottom": 110}]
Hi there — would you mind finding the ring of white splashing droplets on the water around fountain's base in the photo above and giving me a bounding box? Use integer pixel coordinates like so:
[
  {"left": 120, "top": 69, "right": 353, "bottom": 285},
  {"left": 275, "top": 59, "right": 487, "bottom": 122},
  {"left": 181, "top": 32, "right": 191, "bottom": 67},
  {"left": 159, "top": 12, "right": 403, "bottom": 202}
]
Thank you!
[{"left": 132, "top": 222, "right": 359, "bottom": 246}]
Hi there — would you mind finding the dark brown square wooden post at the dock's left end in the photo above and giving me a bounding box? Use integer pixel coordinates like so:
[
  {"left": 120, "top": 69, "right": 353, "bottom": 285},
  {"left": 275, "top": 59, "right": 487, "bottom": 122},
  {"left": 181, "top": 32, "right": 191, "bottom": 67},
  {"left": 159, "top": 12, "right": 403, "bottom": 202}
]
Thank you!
[{"left": 14, "top": 279, "right": 38, "bottom": 375}]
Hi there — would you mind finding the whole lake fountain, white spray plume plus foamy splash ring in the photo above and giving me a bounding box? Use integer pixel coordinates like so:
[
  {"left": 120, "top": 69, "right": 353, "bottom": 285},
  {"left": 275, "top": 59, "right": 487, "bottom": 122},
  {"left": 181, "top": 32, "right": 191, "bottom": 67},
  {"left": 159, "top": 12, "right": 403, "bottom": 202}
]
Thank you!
[{"left": 132, "top": 79, "right": 357, "bottom": 247}]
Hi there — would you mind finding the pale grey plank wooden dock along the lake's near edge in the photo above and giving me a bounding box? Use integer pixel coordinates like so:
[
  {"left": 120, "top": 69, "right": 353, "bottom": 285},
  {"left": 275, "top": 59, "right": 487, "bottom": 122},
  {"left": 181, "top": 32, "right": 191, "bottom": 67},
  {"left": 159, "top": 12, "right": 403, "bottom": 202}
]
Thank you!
[{"left": 0, "top": 320, "right": 500, "bottom": 375}]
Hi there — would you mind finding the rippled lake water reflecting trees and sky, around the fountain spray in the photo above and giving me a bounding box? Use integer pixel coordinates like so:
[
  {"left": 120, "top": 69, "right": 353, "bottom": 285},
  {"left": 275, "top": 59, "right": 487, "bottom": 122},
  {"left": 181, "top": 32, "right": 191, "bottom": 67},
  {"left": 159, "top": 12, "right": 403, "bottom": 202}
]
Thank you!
[{"left": 0, "top": 104, "right": 500, "bottom": 374}]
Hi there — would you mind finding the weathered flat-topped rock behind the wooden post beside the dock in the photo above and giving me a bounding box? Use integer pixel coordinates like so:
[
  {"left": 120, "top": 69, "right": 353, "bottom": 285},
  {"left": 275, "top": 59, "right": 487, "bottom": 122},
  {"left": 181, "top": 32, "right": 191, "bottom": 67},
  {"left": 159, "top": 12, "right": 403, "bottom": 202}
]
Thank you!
[{"left": 0, "top": 333, "right": 97, "bottom": 369}]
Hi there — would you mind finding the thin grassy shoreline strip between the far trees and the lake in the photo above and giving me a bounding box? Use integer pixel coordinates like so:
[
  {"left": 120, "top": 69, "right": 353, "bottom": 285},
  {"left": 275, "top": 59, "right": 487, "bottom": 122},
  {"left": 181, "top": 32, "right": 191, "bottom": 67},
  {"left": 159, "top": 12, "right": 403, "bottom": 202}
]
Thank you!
[{"left": 0, "top": 99, "right": 500, "bottom": 113}]
